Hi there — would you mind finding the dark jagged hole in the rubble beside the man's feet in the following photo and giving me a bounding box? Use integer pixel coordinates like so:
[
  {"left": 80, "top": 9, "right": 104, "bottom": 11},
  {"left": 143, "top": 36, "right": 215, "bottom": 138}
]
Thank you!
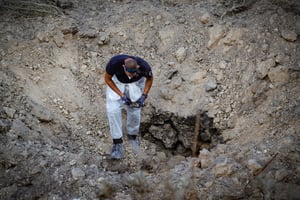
[{"left": 141, "top": 111, "right": 223, "bottom": 156}]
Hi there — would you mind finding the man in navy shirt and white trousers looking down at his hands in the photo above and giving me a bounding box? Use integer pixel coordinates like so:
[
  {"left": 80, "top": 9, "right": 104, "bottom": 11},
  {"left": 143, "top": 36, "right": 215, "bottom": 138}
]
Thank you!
[{"left": 104, "top": 54, "right": 153, "bottom": 159}]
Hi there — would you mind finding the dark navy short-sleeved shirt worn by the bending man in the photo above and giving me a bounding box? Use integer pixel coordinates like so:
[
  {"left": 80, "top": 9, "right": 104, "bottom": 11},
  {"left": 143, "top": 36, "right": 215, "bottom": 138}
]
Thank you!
[{"left": 105, "top": 54, "right": 152, "bottom": 83}]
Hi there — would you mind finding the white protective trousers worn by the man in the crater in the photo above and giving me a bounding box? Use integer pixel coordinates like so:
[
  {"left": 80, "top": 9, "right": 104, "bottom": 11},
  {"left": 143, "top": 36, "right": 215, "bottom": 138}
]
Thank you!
[{"left": 106, "top": 76, "right": 145, "bottom": 139}]
